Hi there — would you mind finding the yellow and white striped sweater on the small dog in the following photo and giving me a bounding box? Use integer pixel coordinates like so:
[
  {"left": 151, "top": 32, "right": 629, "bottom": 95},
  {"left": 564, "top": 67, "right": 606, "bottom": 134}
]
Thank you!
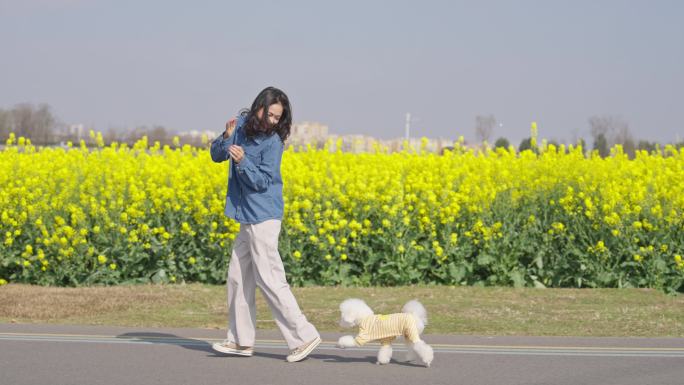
[{"left": 354, "top": 313, "right": 420, "bottom": 346}]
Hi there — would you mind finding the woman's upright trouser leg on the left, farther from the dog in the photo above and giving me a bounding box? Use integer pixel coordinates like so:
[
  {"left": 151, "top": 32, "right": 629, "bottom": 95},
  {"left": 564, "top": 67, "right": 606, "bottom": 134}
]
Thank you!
[{"left": 226, "top": 225, "right": 256, "bottom": 346}]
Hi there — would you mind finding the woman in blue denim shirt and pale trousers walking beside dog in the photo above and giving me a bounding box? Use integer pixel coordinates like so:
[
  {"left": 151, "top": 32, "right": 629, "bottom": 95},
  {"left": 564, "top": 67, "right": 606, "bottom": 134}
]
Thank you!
[{"left": 211, "top": 87, "right": 321, "bottom": 362}]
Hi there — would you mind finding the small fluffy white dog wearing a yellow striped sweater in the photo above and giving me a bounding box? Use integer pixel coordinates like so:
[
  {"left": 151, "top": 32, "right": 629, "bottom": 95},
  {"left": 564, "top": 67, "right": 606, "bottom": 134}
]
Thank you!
[{"left": 337, "top": 298, "right": 434, "bottom": 367}]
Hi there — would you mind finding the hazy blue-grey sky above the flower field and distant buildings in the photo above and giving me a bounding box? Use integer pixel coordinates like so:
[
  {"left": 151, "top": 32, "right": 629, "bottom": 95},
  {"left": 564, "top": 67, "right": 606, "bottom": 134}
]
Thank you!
[{"left": 0, "top": 0, "right": 684, "bottom": 144}]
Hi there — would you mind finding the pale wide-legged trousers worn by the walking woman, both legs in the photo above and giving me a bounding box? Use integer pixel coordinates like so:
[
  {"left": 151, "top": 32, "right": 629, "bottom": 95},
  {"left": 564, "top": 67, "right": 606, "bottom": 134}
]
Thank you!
[{"left": 227, "top": 219, "right": 320, "bottom": 349}]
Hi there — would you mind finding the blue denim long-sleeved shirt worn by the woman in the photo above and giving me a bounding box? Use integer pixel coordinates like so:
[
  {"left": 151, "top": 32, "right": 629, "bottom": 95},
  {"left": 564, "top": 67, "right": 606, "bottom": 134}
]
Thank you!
[{"left": 210, "top": 116, "right": 284, "bottom": 224}]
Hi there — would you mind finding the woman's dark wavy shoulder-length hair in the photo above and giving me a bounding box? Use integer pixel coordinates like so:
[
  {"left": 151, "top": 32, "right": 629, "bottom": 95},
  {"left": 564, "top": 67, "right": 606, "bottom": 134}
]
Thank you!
[{"left": 240, "top": 87, "right": 292, "bottom": 143}]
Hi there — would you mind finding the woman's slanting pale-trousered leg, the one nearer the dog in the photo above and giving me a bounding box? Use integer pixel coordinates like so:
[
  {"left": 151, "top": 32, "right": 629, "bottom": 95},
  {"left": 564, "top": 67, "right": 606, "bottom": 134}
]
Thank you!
[{"left": 247, "top": 220, "right": 320, "bottom": 349}]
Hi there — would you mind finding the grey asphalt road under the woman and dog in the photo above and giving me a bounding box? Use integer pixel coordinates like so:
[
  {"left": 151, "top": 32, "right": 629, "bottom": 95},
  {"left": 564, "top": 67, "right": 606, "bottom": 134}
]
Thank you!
[{"left": 0, "top": 324, "right": 684, "bottom": 385}]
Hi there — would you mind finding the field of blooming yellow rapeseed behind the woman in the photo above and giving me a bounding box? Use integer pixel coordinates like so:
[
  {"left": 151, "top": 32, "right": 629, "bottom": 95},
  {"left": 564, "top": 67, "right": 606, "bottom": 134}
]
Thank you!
[{"left": 0, "top": 133, "right": 684, "bottom": 291}]
